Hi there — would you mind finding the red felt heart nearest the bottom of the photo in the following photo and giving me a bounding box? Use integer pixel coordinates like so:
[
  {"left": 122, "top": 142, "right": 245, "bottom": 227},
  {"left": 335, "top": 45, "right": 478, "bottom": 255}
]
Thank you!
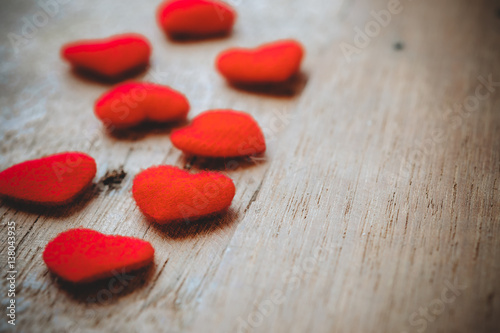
[{"left": 43, "top": 228, "right": 154, "bottom": 283}]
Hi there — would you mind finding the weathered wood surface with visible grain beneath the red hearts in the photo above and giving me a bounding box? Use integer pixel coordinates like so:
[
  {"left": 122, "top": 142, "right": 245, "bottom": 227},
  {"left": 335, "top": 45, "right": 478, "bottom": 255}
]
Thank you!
[{"left": 0, "top": 0, "right": 500, "bottom": 333}]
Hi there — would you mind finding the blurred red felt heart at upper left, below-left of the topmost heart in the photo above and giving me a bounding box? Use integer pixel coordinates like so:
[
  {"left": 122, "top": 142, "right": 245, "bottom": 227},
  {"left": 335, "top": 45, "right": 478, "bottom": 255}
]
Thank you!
[{"left": 61, "top": 34, "right": 151, "bottom": 79}]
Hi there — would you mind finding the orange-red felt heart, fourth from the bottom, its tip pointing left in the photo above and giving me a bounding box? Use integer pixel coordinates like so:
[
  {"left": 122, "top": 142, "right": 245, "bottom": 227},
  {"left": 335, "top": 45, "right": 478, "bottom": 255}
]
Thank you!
[{"left": 170, "top": 110, "right": 266, "bottom": 157}]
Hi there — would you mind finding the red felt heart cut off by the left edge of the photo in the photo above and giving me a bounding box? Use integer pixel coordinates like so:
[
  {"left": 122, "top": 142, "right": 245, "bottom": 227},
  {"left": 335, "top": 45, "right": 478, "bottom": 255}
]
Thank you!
[{"left": 0, "top": 152, "right": 96, "bottom": 205}]
